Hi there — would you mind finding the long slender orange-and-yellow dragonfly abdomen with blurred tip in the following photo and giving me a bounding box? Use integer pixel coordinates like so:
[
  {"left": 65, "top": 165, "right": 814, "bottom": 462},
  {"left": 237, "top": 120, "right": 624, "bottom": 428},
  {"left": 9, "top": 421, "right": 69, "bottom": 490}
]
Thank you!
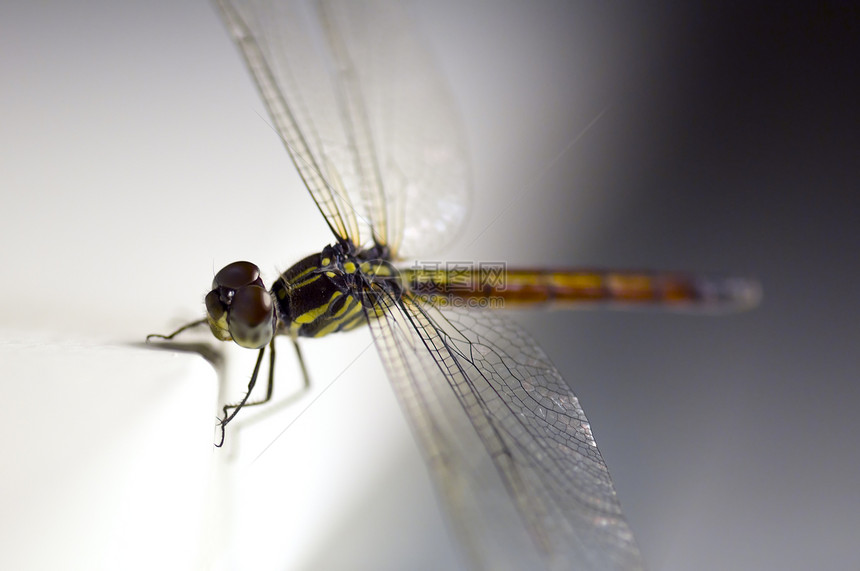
[{"left": 404, "top": 269, "right": 759, "bottom": 311}]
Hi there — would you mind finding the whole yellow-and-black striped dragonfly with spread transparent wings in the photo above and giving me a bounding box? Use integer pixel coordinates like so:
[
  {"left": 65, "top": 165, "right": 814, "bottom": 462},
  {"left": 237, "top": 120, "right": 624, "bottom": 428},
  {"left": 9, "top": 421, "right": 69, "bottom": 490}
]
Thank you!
[{"left": 150, "top": 0, "right": 758, "bottom": 570}]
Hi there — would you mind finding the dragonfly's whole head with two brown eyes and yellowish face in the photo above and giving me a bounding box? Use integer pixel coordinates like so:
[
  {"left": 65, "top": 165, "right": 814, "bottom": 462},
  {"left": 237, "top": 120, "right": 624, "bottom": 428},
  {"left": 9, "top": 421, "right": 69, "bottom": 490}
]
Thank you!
[{"left": 206, "top": 262, "right": 277, "bottom": 349}]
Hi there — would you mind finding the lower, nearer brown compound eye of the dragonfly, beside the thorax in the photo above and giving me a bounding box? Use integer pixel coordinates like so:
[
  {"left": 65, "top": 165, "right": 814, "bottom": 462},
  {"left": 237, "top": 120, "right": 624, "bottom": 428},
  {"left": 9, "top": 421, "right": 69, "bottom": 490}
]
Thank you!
[{"left": 227, "top": 284, "right": 275, "bottom": 349}]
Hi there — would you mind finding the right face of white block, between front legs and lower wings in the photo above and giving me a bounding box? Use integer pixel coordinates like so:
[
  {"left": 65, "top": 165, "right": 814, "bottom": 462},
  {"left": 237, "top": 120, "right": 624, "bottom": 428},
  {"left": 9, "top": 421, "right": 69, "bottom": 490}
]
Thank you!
[{"left": 212, "top": 332, "right": 459, "bottom": 571}]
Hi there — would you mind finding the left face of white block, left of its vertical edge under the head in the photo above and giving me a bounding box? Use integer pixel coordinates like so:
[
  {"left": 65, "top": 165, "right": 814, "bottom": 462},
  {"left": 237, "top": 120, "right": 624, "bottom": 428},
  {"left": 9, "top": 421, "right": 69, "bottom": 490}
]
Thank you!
[{"left": 0, "top": 331, "right": 217, "bottom": 570}]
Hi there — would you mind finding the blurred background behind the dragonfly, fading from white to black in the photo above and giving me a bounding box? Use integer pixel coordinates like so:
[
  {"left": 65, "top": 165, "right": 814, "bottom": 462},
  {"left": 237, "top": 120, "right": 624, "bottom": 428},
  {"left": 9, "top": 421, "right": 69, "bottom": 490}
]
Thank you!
[{"left": 0, "top": 1, "right": 860, "bottom": 570}]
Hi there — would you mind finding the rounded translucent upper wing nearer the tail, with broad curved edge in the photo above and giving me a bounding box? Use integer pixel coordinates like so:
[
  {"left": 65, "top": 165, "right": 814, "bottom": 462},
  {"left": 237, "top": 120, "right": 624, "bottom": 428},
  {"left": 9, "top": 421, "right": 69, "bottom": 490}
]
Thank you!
[{"left": 322, "top": 0, "right": 470, "bottom": 255}]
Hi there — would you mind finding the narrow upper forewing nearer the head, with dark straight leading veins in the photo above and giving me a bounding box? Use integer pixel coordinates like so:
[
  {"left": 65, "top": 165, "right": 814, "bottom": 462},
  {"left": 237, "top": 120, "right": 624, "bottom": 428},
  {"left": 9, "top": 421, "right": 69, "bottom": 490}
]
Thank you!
[{"left": 216, "top": 0, "right": 360, "bottom": 243}]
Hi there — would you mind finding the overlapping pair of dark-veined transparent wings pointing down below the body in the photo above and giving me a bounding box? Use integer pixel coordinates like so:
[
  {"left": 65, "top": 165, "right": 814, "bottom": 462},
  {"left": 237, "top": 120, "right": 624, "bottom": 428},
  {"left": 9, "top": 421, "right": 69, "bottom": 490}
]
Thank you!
[{"left": 370, "top": 290, "right": 643, "bottom": 570}]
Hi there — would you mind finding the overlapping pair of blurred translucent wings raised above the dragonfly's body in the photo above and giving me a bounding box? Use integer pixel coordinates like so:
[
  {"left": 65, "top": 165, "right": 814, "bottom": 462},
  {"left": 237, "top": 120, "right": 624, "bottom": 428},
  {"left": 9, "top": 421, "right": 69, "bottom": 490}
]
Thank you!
[{"left": 218, "top": 0, "right": 470, "bottom": 255}]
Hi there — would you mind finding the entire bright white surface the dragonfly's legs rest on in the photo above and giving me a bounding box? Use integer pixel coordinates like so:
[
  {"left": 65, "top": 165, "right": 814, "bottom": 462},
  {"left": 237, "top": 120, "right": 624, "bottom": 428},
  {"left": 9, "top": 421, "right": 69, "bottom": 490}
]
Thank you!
[{"left": 0, "top": 331, "right": 458, "bottom": 570}]
